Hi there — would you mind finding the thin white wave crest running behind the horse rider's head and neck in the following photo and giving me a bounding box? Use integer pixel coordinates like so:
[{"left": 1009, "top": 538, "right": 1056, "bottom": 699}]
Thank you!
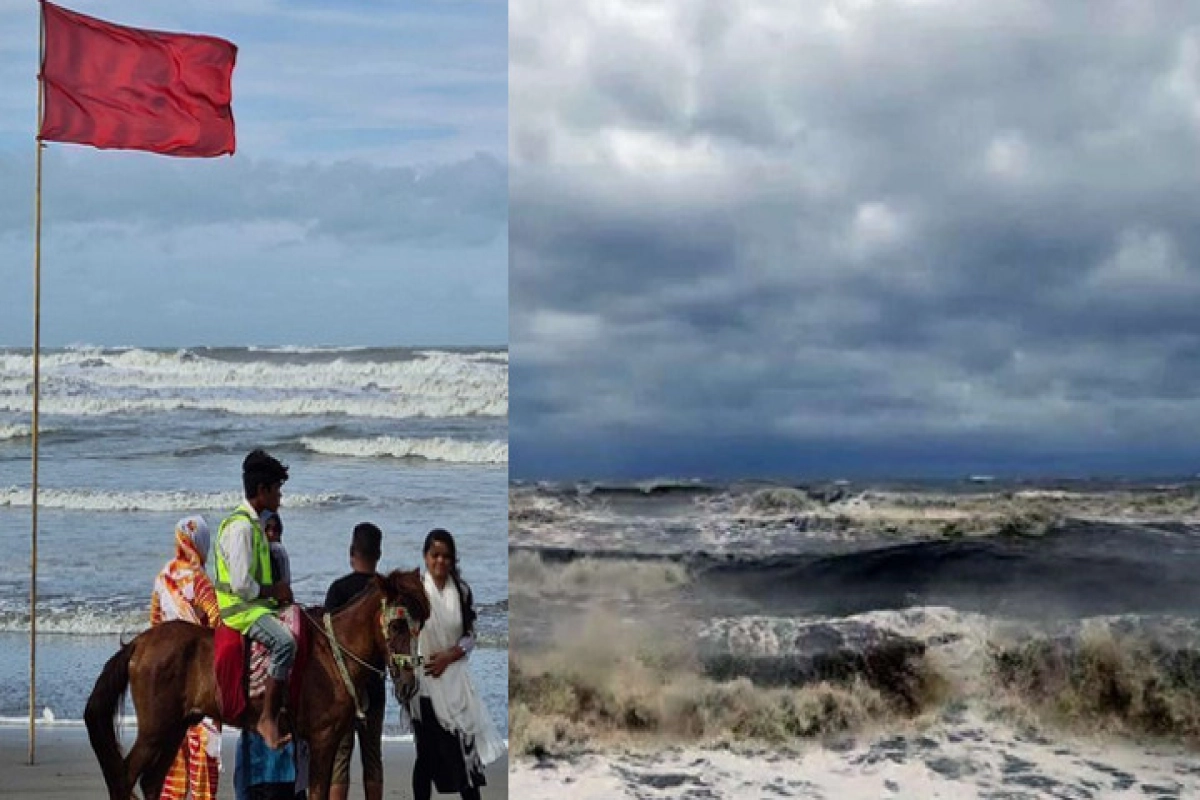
[{"left": 0, "top": 487, "right": 366, "bottom": 511}]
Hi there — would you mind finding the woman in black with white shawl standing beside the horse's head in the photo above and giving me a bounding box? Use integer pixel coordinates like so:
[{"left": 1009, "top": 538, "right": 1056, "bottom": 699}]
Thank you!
[{"left": 410, "top": 528, "right": 505, "bottom": 800}]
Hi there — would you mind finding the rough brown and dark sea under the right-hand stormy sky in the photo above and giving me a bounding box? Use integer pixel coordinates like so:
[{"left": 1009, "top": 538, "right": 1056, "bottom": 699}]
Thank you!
[{"left": 509, "top": 481, "right": 1200, "bottom": 800}]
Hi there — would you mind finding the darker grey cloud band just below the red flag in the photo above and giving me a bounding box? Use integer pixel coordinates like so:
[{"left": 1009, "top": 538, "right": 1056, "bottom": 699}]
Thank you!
[{"left": 0, "top": 149, "right": 508, "bottom": 246}]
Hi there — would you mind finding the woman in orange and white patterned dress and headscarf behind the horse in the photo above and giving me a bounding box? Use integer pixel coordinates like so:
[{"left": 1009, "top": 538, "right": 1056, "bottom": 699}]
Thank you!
[{"left": 150, "top": 516, "right": 221, "bottom": 800}]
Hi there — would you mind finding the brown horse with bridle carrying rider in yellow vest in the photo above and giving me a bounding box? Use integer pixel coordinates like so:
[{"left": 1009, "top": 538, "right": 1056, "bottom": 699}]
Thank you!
[{"left": 84, "top": 570, "right": 430, "bottom": 800}]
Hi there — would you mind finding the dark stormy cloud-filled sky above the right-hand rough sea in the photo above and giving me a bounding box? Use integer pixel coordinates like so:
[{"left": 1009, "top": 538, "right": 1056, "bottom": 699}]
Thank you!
[{"left": 509, "top": 0, "right": 1200, "bottom": 477}]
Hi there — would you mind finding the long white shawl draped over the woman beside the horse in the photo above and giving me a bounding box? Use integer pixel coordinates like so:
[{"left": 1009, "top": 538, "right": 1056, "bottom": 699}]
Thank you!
[{"left": 413, "top": 572, "right": 505, "bottom": 768}]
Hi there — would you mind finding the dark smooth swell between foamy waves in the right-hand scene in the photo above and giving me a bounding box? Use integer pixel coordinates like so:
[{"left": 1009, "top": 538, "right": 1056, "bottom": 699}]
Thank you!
[{"left": 510, "top": 522, "right": 1200, "bottom": 618}]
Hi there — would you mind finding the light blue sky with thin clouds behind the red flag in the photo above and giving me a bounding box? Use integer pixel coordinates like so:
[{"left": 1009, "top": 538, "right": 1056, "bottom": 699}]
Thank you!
[{"left": 0, "top": 0, "right": 508, "bottom": 347}]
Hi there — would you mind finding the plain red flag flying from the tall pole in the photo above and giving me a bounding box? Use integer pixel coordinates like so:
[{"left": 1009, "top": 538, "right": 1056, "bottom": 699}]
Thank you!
[{"left": 38, "top": 0, "right": 238, "bottom": 157}]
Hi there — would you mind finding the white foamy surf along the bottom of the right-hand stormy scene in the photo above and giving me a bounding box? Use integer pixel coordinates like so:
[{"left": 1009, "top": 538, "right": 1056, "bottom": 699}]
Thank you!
[{"left": 509, "top": 712, "right": 1200, "bottom": 800}]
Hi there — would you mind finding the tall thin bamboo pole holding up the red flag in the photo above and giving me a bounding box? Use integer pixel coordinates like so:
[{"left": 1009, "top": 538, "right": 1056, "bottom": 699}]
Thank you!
[{"left": 29, "top": 4, "right": 46, "bottom": 765}]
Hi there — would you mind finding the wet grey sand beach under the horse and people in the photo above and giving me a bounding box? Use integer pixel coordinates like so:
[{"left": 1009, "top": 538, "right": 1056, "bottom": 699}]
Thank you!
[{"left": 0, "top": 726, "right": 509, "bottom": 800}]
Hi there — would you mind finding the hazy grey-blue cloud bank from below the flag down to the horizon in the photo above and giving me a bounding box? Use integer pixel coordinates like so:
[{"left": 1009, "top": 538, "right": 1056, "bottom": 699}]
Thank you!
[{"left": 0, "top": 149, "right": 508, "bottom": 347}]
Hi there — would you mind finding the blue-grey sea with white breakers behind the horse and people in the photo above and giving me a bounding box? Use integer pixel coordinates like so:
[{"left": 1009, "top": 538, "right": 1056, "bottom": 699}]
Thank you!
[{"left": 0, "top": 347, "right": 509, "bottom": 736}]
